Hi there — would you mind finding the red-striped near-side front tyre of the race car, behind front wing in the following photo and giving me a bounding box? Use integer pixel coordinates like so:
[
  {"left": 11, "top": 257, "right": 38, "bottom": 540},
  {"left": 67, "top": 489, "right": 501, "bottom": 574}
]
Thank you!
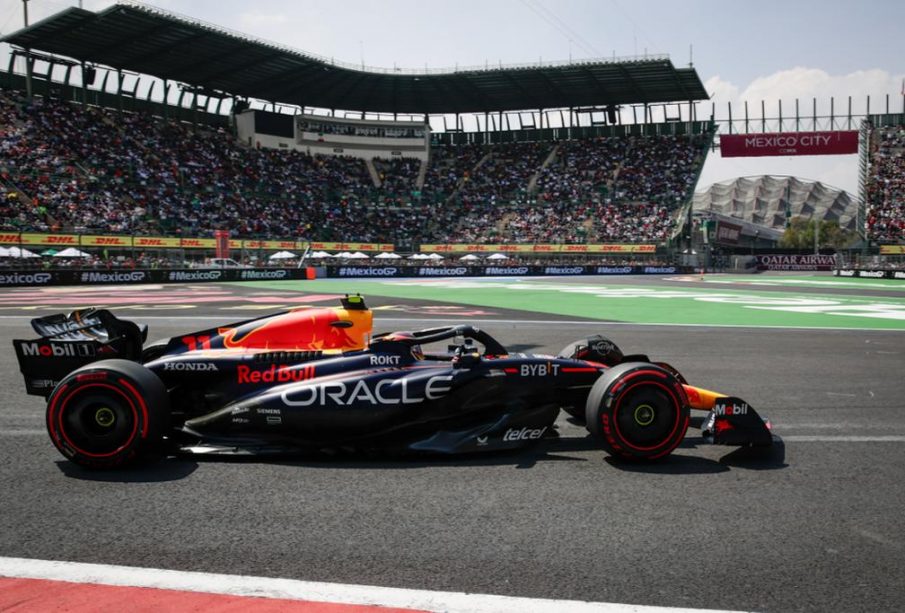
[{"left": 585, "top": 362, "right": 690, "bottom": 460}]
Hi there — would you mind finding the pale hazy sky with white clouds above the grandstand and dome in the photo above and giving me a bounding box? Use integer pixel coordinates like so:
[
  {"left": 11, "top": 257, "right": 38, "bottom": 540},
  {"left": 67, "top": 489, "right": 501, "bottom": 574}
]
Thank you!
[{"left": 0, "top": 0, "right": 905, "bottom": 194}]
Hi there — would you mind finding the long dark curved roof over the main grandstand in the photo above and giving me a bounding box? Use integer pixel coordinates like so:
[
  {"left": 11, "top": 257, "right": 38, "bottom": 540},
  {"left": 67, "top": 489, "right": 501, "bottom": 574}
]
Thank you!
[{"left": 2, "top": 3, "right": 708, "bottom": 115}]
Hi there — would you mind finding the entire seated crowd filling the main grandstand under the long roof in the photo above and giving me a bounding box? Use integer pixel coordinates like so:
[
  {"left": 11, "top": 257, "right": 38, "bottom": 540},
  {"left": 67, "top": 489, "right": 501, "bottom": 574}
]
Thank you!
[{"left": 0, "top": 91, "right": 712, "bottom": 244}]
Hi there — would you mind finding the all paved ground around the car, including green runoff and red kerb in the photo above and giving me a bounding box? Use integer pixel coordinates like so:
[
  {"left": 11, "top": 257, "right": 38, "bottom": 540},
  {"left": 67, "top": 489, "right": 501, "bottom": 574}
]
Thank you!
[{"left": 0, "top": 275, "right": 905, "bottom": 613}]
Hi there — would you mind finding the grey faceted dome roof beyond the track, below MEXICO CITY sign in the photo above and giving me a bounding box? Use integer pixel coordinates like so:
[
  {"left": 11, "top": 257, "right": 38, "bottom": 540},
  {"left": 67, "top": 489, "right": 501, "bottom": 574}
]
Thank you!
[{"left": 693, "top": 175, "right": 858, "bottom": 231}]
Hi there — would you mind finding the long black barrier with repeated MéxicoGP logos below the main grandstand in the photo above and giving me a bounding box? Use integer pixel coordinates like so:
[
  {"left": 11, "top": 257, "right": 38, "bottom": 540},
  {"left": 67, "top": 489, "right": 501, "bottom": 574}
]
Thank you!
[{"left": 0, "top": 265, "right": 690, "bottom": 287}]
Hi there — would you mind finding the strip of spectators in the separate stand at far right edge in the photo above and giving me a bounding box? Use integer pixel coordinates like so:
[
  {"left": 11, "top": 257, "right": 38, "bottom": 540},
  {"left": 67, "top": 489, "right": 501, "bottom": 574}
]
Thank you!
[{"left": 867, "top": 126, "right": 905, "bottom": 243}]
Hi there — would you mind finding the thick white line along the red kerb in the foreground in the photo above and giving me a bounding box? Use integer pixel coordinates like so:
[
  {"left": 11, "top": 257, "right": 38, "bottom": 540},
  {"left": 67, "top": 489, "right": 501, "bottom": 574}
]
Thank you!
[{"left": 0, "top": 557, "right": 744, "bottom": 613}]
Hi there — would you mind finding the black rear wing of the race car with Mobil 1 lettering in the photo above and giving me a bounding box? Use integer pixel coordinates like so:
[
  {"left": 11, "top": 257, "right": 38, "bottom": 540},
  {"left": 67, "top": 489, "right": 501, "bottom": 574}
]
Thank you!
[{"left": 13, "top": 308, "right": 148, "bottom": 397}]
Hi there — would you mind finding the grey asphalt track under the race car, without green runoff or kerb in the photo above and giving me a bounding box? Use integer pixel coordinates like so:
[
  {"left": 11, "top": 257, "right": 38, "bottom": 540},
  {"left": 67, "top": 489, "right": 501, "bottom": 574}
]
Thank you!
[{"left": 0, "top": 280, "right": 905, "bottom": 611}]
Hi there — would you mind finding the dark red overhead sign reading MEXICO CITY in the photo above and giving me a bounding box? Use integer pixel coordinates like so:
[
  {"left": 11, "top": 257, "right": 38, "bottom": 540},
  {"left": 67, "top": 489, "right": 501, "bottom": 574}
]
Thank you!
[{"left": 720, "top": 130, "right": 858, "bottom": 158}]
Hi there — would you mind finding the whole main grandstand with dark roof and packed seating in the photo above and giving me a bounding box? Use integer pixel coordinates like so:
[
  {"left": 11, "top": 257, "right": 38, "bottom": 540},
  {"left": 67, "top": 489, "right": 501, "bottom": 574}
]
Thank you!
[{"left": 0, "top": 3, "right": 712, "bottom": 262}]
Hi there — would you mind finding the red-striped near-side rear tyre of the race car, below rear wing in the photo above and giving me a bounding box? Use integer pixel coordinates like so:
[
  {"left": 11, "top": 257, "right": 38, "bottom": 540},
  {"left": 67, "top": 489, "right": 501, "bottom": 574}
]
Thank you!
[{"left": 46, "top": 360, "right": 170, "bottom": 468}]
